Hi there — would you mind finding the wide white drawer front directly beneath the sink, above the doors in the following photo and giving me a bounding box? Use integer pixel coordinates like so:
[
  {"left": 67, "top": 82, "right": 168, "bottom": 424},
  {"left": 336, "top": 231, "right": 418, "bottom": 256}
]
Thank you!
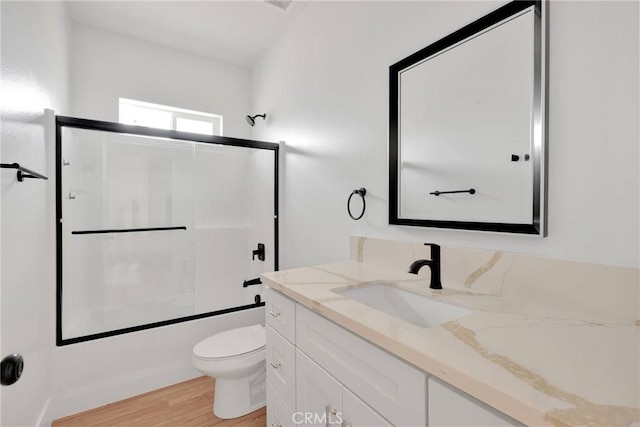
[{"left": 296, "top": 305, "right": 427, "bottom": 426}]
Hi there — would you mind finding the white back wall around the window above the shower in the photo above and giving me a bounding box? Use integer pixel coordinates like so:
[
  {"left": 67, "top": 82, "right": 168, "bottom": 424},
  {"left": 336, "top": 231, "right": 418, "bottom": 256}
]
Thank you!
[{"left": 71, "top": 23, "right": 251, "bottom": 138}]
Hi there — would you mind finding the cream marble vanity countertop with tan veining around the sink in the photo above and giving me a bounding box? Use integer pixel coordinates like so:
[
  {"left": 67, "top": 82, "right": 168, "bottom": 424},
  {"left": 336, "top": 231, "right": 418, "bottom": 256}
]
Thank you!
[{"left": 262, "top": 262, "right": 640, "bottom": 426}]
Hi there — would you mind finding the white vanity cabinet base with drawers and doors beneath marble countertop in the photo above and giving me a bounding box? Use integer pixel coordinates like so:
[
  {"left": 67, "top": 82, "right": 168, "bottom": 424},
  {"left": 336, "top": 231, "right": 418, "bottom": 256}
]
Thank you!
[{"left": 265, "top": 289, "right": 522, "bottom": 427}]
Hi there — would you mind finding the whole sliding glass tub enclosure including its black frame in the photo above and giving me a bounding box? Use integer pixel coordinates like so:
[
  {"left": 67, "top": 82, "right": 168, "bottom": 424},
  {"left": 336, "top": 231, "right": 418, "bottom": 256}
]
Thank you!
[{"left": 56, "top": 117, "right": 278, "bottom": 345}]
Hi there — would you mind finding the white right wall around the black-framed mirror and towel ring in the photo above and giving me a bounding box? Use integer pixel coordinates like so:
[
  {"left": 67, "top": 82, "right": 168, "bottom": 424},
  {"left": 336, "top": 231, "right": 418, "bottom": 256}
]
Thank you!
[{"left": 252, "top": 1, "right": 640, "bottom": 268}]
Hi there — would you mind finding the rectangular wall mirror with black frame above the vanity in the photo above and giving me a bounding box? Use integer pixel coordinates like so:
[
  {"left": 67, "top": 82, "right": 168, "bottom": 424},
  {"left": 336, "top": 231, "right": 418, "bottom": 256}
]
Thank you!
[{"left": 389, "top": 1, "right": 545, "bottom": 235}]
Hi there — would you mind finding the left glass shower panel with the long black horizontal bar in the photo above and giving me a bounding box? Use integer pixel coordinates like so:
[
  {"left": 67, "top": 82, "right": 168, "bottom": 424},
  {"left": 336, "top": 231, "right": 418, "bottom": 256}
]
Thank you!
[{"left": 61, "top": 128, "right": 195, "bottom": 340}]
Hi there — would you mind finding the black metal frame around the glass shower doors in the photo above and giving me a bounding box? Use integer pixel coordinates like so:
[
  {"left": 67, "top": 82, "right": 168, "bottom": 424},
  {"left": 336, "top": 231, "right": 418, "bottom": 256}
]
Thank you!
[{"left": 55, "top": 116, "right": 280, "bottom": 347}]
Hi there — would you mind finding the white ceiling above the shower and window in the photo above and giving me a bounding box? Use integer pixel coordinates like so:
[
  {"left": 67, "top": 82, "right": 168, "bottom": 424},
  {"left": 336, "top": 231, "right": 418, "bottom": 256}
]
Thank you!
[{"left": 67, "top": 0, "right": 306, "bottom": 67}]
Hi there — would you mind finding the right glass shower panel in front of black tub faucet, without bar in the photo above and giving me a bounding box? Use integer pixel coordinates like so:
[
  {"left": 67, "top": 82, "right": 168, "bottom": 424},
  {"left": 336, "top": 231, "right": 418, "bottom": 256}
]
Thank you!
[{"left": 194, "top": 143, "right": 277, "bottom": 313}]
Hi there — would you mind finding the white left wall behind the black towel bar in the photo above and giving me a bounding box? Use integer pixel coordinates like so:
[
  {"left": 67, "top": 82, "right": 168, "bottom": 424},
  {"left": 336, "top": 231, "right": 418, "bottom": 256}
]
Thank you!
[{"left": 0, "top": 1, "right": 70, "bottom": 426}]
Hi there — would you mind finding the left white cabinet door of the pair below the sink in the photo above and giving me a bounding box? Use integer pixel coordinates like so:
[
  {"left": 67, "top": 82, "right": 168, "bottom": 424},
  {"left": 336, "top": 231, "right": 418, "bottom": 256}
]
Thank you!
[{"left": 294, "top": 350, "right": 342, "bottom": 427}]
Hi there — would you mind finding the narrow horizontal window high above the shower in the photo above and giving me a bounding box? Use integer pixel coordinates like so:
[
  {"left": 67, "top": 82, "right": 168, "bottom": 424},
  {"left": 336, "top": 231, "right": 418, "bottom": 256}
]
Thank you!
[{"left": 120, "top": 98, "right": 222, "bottom": 136}]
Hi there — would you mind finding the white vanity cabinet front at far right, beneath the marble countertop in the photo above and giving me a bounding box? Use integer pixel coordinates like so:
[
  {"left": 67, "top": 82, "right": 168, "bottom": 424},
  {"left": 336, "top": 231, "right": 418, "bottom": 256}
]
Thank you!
[{"left": 427, "top": 377, "right": 523, "bottom": 427}]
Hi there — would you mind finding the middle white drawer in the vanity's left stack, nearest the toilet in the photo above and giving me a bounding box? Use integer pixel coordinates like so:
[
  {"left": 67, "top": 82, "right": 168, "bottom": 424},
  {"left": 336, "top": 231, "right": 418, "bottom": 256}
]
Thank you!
[{"left": 266, "top": 326, "right": 296, "bottom": 408}]
